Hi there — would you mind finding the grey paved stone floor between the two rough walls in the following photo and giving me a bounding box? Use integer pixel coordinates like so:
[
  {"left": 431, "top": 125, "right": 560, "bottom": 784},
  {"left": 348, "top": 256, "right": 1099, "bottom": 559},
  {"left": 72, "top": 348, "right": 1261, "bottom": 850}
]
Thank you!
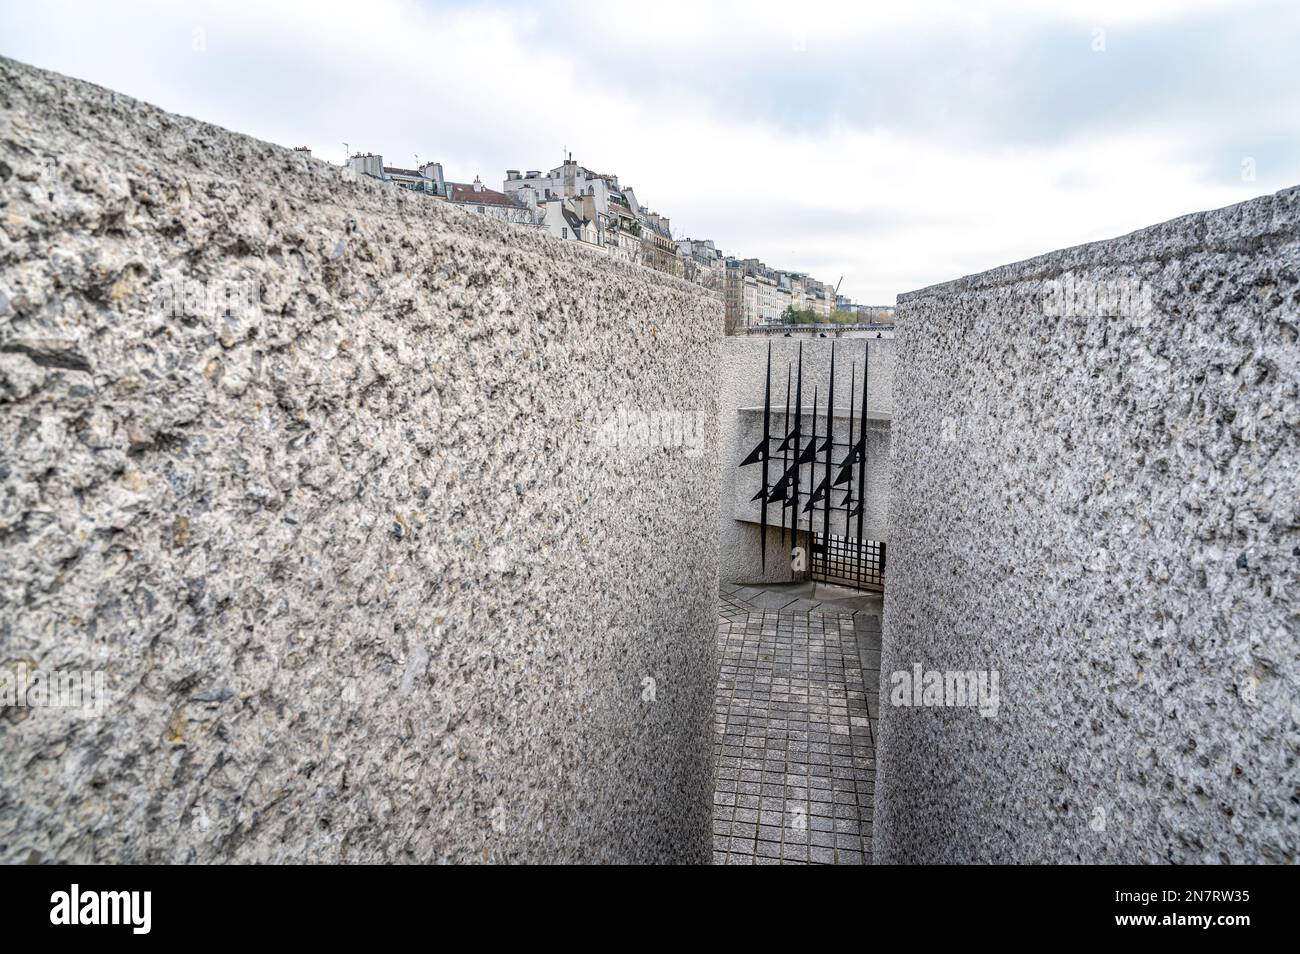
[{"left": 714, "top": 586, "right": 880, "bottom": 864}]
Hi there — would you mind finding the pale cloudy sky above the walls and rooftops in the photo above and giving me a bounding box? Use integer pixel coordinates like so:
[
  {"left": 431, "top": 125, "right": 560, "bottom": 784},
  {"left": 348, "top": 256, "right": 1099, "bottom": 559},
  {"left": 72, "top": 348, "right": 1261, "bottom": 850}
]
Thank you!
[{"left": 0, "top": 0, "right": 1300, "bottom": 304}]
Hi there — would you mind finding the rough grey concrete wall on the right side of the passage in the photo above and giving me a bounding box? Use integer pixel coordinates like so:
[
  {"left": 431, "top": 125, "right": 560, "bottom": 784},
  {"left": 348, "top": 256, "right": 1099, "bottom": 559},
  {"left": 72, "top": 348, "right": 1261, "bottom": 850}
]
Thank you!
[{"left": 875, "top": 188, "right": 1300, "bottom": 862}]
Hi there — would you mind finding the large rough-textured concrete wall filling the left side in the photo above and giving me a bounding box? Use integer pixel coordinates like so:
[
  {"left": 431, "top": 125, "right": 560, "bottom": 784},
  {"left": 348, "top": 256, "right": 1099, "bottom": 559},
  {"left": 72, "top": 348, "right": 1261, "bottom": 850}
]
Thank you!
[{"left": 0, "top": 60, "right": 723, "bottom": 862}]
